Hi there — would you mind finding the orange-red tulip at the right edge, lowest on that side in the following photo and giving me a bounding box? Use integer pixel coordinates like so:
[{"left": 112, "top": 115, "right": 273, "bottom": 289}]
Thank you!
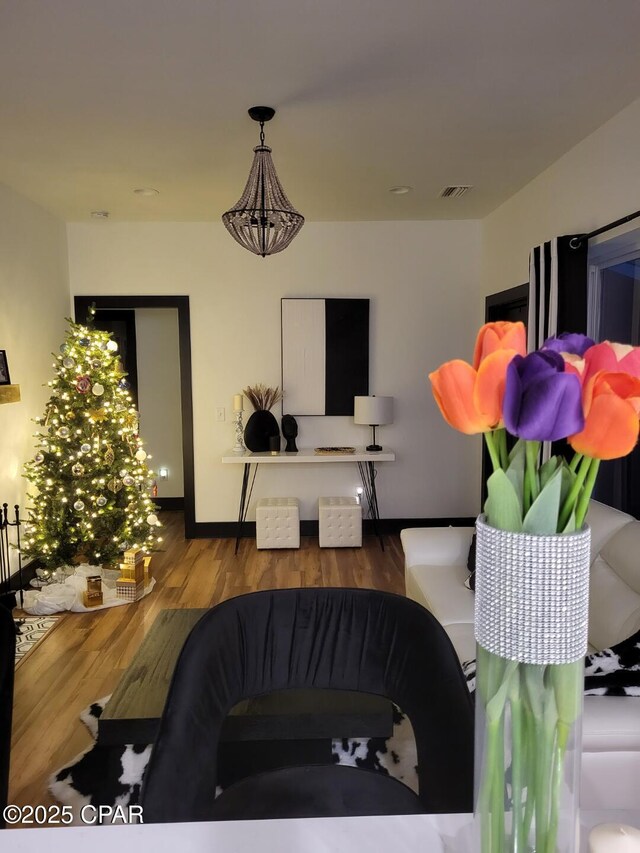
[{"left": 569, "top": 371, "right": 640, "bottom": 459}]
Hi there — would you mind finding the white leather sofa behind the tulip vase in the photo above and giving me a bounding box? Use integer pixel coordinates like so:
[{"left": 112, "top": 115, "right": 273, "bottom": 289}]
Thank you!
[{"left": 400, "top": 501, "right": 640, "bottom": 809}]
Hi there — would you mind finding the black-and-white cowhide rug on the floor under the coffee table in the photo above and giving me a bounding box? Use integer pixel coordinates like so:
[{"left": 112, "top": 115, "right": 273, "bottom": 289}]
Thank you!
[{"left": 49, "top": 696, "right": 418, "bottom": 819}]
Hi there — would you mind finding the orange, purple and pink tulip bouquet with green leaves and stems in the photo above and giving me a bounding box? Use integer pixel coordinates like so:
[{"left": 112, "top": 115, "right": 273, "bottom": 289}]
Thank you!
[{"left": 429, "top": 322, "right": 640, "bottom": 853}]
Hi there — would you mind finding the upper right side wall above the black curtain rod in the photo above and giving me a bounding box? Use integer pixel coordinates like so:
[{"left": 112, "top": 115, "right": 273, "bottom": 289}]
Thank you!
[{"left": 482, "top": 95, "right": 640, "bottom": 294}]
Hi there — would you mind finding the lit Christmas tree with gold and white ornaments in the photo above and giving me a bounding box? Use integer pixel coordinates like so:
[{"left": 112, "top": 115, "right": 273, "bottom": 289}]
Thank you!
[{"left": 23, "top": 312, "right": 160, "bottom": 568}]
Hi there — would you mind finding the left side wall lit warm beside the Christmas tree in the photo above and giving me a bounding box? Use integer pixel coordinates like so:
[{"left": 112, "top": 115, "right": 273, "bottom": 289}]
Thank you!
[{"left": 0, "top": 185, "right": 71, "bottom": 514}]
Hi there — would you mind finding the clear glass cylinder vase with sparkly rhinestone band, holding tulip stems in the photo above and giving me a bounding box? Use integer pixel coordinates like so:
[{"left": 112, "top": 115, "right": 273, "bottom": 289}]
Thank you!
[{"left": 474, "top": 516, "right": 590, "bottom": 853}]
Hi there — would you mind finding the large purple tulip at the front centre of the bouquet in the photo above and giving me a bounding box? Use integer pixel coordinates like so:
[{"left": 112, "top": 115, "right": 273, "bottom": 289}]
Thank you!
[{"left": 502, "top": 350, "right": 584, "bottom": 441}]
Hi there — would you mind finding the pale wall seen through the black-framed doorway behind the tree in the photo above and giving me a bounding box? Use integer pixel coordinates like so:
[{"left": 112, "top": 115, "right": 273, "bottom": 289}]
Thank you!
[{"left": 135, "top": 308, "right": 184, "bottom": 498}]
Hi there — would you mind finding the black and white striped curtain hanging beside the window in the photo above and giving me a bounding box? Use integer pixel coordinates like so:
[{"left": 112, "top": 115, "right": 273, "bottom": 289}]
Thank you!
[{"left": 527, "top": 234, "right": 587, "bottom": 351}]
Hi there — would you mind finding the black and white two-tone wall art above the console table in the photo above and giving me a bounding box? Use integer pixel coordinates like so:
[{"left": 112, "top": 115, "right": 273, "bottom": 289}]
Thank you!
[{"left": 282, "top": 299, "right": 369, "bottom": 415}]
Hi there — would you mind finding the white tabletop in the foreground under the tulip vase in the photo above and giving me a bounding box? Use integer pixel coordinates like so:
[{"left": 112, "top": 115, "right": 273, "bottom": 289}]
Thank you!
[{"left": 2, "top": 811, "right": 640, "bottom": 853}]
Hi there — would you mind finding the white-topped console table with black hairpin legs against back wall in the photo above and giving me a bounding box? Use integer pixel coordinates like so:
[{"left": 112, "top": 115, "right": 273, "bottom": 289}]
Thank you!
[{"left": 222, "top": 447, "right": 396, "bottom": 554}]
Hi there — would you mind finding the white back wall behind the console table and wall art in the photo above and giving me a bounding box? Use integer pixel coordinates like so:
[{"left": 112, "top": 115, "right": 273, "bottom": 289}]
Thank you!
[{"left": 68, "top": 221, "right": 483, "bottom": 521}]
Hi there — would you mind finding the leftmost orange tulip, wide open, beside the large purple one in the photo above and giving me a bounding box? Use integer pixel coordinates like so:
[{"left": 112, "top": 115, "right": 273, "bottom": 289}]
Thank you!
[{"left": 429, "top": 349, "right": 516, "bottom": 435}]
